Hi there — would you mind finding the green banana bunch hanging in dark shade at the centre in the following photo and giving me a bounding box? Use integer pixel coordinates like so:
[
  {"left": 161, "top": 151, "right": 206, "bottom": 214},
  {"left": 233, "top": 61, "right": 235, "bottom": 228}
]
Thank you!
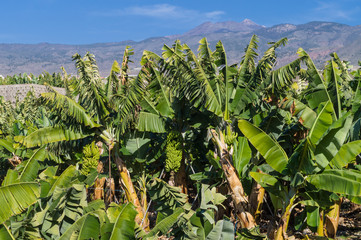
[{"left": 165, "top": 131, "right": 182, "bottom": 172}]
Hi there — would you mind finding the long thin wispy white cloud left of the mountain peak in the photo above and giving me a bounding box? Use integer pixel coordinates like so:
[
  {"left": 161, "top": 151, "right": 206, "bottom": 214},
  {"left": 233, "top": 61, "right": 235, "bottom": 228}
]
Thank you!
[{"left": 92, "top": 4, "right": 225, "bottom": 22}]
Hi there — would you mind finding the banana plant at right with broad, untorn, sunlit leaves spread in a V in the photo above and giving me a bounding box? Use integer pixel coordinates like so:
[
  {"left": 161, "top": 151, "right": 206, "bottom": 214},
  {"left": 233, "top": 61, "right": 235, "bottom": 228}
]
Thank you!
[{"left": 239, "top": 102, "right": 361, "bottom": 239}]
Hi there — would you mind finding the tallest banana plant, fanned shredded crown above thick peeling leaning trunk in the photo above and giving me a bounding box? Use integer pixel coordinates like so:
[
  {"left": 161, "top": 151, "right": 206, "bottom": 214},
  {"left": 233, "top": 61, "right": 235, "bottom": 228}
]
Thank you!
[{"left": 140, "top": 36, "right": 310, "bottom": 228}]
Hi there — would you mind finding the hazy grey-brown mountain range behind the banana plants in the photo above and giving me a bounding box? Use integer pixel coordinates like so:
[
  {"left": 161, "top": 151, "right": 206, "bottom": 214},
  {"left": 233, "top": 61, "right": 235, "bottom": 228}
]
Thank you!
[{"left": 0, "top": 19, "right": 361, "bottom": 76}]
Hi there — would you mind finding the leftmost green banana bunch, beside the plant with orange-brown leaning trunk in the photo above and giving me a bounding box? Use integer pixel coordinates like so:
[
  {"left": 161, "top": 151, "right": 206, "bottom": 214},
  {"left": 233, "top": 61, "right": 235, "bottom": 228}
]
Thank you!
[{"left": 80, "top": 142, "right": 100, "bottom": 175}]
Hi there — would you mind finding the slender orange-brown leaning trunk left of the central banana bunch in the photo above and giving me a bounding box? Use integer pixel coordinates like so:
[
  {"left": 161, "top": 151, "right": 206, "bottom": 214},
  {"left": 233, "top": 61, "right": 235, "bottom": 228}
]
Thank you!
[{"left": 115, "top": 156, "right": 144, "bottom": 225}]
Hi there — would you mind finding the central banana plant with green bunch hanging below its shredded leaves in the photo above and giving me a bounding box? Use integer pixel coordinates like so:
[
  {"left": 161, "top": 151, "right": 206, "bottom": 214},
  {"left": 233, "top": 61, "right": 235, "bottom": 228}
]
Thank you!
[{"left": 138, "top": 39, "right": 222, "bottom": 192}]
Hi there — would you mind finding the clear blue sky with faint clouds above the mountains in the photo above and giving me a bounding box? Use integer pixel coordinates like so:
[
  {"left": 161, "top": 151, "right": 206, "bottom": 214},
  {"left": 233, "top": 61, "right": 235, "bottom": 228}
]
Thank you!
[{"left": 0, "top": 0, "right": 361, "bottom": 44}]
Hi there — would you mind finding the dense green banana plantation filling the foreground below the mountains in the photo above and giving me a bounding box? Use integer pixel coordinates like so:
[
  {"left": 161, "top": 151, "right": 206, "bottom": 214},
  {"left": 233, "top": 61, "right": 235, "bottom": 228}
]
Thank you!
[{"left": 0, "top": 36, "right": 361, "bottom": 240}]
